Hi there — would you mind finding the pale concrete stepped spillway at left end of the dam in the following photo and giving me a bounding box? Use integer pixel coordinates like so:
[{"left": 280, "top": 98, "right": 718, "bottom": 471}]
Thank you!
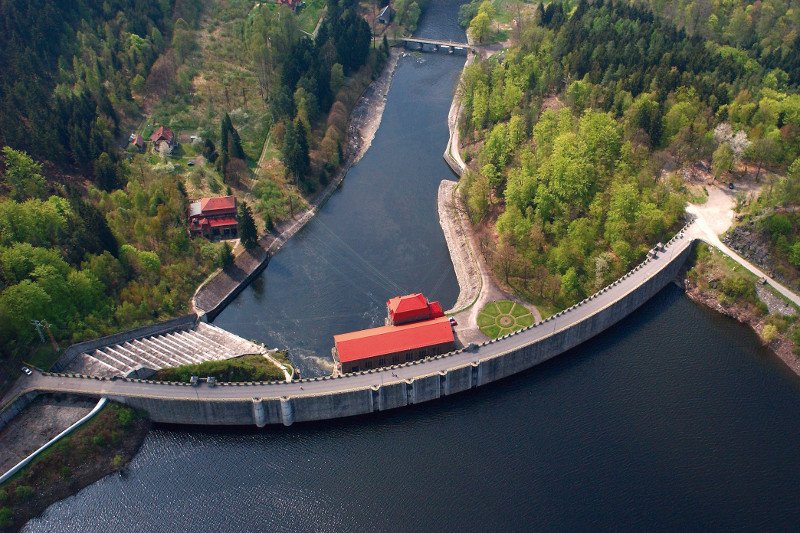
[{"left": 71, "top": 322, "right": 266, "bottom": 376}]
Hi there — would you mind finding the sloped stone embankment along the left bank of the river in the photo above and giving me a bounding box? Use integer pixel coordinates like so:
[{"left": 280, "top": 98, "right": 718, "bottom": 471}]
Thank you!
[{"left": 192, "top": 50, "right": 400, "bottom": 320}]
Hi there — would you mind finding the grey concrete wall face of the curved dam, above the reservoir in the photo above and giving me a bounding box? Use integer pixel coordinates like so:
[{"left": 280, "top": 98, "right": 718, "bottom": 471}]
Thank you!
[{"left": 106, "top": 239, "right": 692, "bottom": 427}]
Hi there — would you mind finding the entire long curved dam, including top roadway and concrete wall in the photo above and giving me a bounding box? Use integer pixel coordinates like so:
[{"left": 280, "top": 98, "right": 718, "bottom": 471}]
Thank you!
[{"left": 3, "top": 223, "right": 701, "bottom": 427}]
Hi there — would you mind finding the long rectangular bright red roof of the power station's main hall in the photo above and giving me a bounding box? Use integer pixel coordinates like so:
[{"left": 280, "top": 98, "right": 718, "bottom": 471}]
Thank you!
[{"left": 333, "top": 316, "right": 454, "bottom": 363}]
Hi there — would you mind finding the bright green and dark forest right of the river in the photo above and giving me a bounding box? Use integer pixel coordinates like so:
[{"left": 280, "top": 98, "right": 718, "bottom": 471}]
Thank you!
[{"left": 459, "top": 0, "right": 800, "bottom": 311}]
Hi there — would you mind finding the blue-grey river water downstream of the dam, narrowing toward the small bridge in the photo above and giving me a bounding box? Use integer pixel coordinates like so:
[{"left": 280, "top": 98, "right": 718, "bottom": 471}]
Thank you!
[{"left": 214, "top": 8, "right": 466, "bottom": 377}]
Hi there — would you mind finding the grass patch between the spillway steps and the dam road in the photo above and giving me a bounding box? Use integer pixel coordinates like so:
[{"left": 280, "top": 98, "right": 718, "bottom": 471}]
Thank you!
[{"left": 153, "top": 354, "right": 286, "bottom": 382}]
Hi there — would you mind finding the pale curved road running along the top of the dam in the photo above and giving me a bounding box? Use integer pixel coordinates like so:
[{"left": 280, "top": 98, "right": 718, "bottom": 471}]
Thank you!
[{"left": 4, "top": 225, "right": 699, "bottom": 401}]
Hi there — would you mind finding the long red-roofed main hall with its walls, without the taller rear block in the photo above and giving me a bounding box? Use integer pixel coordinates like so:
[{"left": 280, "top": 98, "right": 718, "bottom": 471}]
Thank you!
[{"left": 333, "top": 316, "right": 455, "bottom": 374}]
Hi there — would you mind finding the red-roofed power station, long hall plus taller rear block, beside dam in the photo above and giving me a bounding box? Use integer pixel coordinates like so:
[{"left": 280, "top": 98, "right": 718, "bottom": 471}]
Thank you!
[{"left": 333, "top": 293, "right": 455, "bottom": 374}]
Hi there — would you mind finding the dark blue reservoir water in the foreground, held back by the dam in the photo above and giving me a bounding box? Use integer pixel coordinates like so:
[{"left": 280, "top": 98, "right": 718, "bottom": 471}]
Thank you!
[{"left": 28, "top": 286, "right": 800, "bottom": 531}]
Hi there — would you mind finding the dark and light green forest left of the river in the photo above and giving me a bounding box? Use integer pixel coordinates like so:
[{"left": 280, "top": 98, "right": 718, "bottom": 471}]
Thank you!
[{"left": 0, "top": 0, "right": 380, "bottom": 388}]
